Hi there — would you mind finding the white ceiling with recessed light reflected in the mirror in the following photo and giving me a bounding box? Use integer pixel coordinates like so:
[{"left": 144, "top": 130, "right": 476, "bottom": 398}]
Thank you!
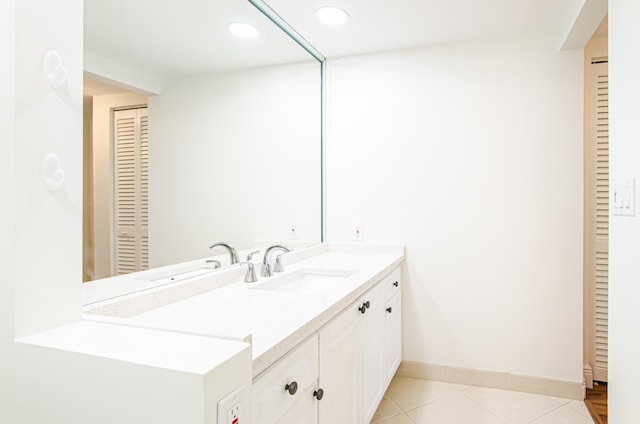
[{"left": 84, "top": 0, "right": 312, "bottom": 82}]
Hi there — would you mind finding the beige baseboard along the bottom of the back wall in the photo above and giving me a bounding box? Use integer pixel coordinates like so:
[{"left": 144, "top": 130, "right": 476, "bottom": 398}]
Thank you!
[{"left": 396, "top": 361, "right": 585, "bottom": 400}]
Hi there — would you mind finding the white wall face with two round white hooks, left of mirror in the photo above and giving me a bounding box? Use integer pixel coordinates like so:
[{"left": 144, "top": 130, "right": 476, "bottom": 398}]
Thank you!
[{"left": 14, "top": 0, "right": 82, "bottom": 336}]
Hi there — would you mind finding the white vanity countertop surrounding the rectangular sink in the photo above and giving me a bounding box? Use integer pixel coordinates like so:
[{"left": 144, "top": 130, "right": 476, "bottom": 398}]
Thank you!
[{"left": 83, "top": 244, "right": 404, "bottom": 377}]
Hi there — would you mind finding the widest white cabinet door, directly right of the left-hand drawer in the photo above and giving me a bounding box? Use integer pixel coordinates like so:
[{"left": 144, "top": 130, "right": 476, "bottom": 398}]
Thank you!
[{"left": 318, "top": 304, "right": 362, "bottom": 424}]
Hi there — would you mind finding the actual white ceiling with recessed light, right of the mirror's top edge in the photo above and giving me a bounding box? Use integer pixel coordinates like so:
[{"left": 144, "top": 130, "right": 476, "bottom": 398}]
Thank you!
[{"left": 266, "top": 0, "right": 589, "bottom": 57}]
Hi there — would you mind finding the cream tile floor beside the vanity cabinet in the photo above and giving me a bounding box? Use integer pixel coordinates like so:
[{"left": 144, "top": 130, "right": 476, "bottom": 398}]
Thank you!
[{"left": 371, "top": 377, "right": 593, "bottom": 424}]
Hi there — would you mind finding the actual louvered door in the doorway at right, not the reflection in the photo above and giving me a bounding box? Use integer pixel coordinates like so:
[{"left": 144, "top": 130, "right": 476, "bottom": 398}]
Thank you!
[{"left": 587, "top": 59, "right": 609, "bottom": 381}]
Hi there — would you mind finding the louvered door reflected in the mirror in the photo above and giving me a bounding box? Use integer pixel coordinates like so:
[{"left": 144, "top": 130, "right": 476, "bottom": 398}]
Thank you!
[{"left": 114, "top": 108, "right": 149, "bottom": 275}]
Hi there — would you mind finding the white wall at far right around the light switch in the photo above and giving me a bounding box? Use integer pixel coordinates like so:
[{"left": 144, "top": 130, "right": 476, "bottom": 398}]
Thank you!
[{"left": 609, "top": 0, "right": 640, "bottom": 423}]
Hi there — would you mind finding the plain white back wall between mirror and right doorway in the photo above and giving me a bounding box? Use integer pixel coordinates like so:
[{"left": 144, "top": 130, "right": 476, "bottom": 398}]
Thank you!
[{"left": 327, "top": 35, "right": 583, "bottom": 382}]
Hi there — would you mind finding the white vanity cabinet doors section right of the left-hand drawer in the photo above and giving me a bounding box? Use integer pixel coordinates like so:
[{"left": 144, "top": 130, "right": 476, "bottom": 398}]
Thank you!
[{"left": 318, "top": 269, "right": 401, "bottom": 424}]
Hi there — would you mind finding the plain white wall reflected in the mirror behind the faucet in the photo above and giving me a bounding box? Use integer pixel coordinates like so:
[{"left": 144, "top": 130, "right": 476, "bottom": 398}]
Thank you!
[{"left": 149, "top": 63, "right": 320, "bottom": 267}]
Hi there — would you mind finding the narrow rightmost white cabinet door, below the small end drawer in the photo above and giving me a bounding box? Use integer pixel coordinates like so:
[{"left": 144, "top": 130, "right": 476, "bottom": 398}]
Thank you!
[{"left": 383, "top": 293, "right": 402, "bottom": 387}]
